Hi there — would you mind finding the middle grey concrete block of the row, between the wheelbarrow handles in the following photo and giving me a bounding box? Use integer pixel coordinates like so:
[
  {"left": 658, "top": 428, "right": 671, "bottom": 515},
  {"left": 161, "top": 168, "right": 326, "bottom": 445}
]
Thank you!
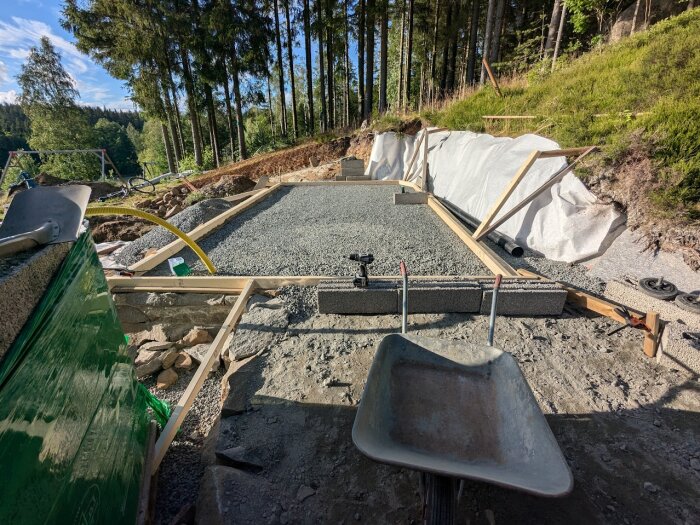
[{"left": 397, "top": 279, "right": 482, "bottom": 314}]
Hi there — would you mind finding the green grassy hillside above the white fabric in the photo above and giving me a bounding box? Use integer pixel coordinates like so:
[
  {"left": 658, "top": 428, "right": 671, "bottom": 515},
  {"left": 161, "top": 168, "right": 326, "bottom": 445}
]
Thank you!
[{"left": 425, "top": 9, "right": 700, "bottom": 223}]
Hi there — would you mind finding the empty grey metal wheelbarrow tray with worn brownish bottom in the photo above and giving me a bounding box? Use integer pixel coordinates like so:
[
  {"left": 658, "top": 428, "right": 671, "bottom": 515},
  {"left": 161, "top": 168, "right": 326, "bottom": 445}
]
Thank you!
[{"left": 352, "top": 334, "right": 573, "bottom": 496}]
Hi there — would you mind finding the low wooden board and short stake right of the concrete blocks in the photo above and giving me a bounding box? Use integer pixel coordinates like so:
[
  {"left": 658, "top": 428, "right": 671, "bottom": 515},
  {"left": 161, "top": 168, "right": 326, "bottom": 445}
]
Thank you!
[{"left": 518, "top": 268, "right": 661, "bottom": 357}]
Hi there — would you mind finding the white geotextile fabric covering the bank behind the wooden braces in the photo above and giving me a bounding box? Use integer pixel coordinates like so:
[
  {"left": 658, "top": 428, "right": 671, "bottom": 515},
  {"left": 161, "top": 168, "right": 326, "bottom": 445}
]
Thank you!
[{"left": 365, "top": 131, "right": 622, "bottom": 262}]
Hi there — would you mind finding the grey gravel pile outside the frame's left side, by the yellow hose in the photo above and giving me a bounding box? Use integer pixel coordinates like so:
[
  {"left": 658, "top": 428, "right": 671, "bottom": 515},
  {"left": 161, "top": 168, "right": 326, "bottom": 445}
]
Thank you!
[{"left": 115, "top": 199, "right": 233, "bottom": 266}]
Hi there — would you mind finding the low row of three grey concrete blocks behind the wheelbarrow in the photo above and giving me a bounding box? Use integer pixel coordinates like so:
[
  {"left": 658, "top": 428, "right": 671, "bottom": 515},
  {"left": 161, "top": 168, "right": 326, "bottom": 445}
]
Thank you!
[{"left": 317, "top": 277, "right": 566, "bottom": 316}]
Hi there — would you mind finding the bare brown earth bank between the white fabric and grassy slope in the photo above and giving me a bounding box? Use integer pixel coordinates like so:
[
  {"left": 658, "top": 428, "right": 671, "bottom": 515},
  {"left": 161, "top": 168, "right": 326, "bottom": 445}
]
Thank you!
[{"left": 586, "top": 138, "right": 700, "bottom": 271}]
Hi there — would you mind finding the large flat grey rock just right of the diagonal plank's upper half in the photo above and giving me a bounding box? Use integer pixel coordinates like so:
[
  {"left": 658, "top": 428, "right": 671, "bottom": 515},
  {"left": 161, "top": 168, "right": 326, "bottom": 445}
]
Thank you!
[{"left": 225, "top": 303, "right": 289, "bottom": 361}]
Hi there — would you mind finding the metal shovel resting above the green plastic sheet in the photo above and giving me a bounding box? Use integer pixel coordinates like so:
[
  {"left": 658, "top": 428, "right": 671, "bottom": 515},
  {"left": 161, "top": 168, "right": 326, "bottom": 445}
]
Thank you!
[{"left": 0, "top": 185, "right": 91, "bottom": 257}]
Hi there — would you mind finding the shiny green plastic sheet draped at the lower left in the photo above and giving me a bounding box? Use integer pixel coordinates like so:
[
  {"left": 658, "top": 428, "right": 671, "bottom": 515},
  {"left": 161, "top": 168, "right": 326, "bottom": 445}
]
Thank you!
[{"left": 0, "top": 233, "right": 149, "bottom": 524}]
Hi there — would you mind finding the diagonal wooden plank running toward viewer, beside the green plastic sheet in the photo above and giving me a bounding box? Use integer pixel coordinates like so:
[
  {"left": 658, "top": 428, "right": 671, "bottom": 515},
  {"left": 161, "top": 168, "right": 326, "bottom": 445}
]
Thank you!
[{"left": 151, "top": 279, "right": 257, "bottom": 474}]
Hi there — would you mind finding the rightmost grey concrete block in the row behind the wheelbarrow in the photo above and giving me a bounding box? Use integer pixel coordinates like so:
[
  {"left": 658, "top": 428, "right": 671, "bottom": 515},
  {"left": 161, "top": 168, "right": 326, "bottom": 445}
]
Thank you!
[{"left": 481, "top": 280, "right": 566, "bottom": 316}]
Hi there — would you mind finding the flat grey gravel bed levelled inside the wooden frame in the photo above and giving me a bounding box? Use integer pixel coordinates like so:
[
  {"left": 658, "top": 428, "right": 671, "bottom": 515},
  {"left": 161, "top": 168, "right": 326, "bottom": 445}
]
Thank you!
[{"left": 153, "top": 185, "right": 490, "bottom": 276}]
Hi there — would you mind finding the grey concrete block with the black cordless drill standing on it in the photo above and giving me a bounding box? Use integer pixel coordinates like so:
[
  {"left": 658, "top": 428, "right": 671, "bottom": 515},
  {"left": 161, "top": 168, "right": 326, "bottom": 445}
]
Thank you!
[{"left": 317, "top": 279, "right": 399, "bottom": 314}]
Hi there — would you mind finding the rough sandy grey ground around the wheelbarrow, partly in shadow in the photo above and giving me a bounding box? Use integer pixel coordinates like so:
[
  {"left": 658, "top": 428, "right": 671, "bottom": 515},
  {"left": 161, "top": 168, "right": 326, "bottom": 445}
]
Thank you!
[{"left": 187, "top": 288, "right": 700, "bottom": 524}]
